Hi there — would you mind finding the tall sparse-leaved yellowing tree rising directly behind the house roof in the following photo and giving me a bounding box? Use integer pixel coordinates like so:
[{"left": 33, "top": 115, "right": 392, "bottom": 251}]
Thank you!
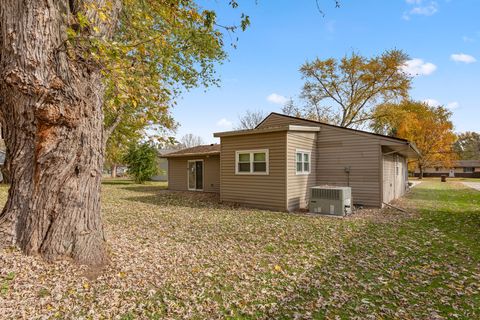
[{"left": 283, "top": 50, "right": 411, "bottom": 128}]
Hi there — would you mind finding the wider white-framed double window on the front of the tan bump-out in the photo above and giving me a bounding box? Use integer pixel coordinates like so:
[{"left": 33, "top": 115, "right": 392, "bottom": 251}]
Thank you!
[{"left": 235, "top": 149, "right": 268, "bottom": 175}]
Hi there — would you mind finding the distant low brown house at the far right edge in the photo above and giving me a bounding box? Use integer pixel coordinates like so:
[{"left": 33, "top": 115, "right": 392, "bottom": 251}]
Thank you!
[{"left": 415, "top": 160, "right": 480, "bottom": 178}]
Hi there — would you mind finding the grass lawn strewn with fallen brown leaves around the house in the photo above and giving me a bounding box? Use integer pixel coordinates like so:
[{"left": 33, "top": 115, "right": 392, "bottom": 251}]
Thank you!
[{"left": 0, "top": 180, "right": 480, "bottom": 319}]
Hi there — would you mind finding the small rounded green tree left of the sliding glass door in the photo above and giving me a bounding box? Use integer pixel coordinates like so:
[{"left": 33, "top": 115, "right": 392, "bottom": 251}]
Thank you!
[{"left": 123, "top": 142, "right": 158, "bottom": 183}]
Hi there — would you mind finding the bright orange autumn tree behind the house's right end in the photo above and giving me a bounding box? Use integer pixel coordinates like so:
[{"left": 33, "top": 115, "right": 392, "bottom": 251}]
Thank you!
[{"left": 371, "top": 100, "right": 456, "bottom": 179}]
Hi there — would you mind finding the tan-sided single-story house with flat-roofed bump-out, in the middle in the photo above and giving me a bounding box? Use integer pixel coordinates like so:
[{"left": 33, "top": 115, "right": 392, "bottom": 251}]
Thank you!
[{"left": 165, "top": 113, "right": 419, "bottom": 211}]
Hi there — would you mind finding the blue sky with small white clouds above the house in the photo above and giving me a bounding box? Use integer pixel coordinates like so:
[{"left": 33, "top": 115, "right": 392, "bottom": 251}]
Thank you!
[{"left": 172, "top": 0, "right": 480, "bottom": 143}]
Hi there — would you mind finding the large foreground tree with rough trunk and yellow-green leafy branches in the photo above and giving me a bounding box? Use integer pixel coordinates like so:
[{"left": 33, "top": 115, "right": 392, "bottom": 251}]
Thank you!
[{"left": 0, "top": 0, "right": 249, "bottom": 265}]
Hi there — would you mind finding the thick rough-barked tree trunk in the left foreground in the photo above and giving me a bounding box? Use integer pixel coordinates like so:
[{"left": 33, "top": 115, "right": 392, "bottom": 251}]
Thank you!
[{"left": 0, "top": 0, "right": 118, "bottom": 265}]
